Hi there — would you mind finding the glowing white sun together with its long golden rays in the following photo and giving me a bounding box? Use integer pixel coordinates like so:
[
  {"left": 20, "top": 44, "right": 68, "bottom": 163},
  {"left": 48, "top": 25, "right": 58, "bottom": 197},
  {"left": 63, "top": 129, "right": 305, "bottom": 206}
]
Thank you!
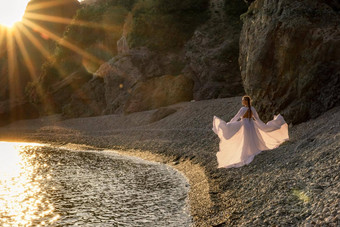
[{"left": 0, "top": 0, "right": 105, "bottom": 108}]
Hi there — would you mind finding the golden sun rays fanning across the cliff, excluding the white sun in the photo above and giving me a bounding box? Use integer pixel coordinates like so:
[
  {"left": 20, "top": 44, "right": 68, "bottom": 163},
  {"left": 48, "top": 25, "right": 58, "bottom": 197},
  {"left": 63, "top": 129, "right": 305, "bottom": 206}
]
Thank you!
[{"left": 0, "top": 0, "right": 121, "bottom": 114}]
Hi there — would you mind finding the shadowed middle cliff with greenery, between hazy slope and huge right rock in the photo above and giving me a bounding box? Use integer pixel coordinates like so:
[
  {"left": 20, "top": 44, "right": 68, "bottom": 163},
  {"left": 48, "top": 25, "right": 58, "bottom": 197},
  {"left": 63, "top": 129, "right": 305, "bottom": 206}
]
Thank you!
[{"left": 59, "top": 0, "right": 247, "bottom": 116}]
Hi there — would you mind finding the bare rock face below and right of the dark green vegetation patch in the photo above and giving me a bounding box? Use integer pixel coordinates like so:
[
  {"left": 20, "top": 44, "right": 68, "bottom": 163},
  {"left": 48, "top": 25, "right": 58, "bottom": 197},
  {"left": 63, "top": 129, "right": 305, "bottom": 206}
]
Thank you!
[{"left": 56, "top": 0, "right": 247, "bottom": 119}]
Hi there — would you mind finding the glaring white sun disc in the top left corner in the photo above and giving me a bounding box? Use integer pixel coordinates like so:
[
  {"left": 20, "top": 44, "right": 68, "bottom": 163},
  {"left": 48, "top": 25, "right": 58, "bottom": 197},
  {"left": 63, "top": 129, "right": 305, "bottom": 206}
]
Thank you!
[{"left": 0, "top": 0, "right": 30, "bottom": 28}]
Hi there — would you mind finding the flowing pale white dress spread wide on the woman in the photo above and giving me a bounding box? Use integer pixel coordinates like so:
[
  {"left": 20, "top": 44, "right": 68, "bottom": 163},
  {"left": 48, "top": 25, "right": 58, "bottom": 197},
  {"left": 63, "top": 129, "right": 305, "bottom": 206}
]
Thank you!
[{"left": 212, "top": 107, "right": 289, "bottom": 168}]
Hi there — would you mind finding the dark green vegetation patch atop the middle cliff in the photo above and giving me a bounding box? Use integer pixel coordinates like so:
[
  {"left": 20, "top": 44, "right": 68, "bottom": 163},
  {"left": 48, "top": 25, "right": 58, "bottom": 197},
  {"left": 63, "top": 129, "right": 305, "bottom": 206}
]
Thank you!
[{"left": 128, "top": 0, "right": 209, "bottom": 51}]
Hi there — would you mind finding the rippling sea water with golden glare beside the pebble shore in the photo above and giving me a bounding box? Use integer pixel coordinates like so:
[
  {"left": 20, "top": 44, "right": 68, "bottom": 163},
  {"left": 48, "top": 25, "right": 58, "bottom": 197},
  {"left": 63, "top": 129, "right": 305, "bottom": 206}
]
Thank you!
[{"left": 0, "top": 142, "right": 192, "bottom": 226}]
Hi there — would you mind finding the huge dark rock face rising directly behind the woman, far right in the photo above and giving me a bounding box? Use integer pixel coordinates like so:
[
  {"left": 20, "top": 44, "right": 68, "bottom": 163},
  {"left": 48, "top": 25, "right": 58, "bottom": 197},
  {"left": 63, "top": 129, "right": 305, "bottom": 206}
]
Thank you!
[{"left": 239, "top": 0, "right": 340, "bottom": 124}]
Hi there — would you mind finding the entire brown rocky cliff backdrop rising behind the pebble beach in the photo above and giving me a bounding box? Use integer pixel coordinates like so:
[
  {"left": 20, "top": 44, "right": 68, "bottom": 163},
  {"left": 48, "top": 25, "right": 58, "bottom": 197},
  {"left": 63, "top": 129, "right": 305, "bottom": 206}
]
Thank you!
[{"left": 0, "top": 0, "right": 340, "bottom": 124}]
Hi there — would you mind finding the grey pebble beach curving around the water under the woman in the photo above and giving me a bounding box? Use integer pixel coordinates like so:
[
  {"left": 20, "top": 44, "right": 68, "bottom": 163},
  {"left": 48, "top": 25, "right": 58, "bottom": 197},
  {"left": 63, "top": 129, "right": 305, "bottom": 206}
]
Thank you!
[{"left": 0, "top": 97, "right": 340, "bottom": 226}]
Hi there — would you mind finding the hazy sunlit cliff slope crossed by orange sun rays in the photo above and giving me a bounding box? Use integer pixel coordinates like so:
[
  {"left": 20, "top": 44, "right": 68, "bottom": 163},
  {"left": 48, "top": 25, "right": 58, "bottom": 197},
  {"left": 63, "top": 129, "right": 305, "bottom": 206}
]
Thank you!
[{"left": 27, "top": 0, "right": 133, "bottom": 113}]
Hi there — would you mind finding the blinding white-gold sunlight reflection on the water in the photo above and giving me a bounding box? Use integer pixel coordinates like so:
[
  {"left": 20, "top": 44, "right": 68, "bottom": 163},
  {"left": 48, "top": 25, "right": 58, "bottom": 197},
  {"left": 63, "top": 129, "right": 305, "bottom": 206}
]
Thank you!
[{"left": 0, "top": 142, "right": 59, "bottom": 226}]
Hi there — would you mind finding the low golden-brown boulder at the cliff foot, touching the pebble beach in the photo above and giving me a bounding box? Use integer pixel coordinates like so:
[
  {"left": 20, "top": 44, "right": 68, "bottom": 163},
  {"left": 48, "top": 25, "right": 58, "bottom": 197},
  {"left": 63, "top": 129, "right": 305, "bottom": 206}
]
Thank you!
[{"left": 124, "top": 75, "right": 193, "bottom": 113}]
